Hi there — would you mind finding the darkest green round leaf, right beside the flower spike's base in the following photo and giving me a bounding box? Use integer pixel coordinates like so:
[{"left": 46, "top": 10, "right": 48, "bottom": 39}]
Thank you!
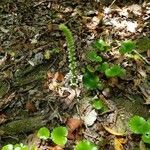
[{"left": 83, "top": 72, "right": 101, "bottom": 90}]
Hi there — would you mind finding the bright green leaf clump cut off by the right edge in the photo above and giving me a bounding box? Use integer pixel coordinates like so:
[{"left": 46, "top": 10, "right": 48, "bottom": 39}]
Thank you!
[{"left": 129, "top": 116, "right": 150, "bottom": 144}]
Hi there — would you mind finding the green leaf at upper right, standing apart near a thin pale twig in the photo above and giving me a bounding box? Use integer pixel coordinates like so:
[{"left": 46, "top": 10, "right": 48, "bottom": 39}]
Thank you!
[{"left": 119, "top": 40, "right": 135, "bottom": 54}]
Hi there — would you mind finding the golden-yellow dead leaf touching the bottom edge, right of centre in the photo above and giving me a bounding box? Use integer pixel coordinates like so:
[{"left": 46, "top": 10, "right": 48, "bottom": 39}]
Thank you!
[{"left": 114, "top": 138, "right": 127, "bottom": 150}]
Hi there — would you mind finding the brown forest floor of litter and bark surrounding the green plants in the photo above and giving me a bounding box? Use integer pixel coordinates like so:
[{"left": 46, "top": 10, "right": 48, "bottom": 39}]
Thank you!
[{"left": 0, "top": 0, "right": 150, "bottom": 150}]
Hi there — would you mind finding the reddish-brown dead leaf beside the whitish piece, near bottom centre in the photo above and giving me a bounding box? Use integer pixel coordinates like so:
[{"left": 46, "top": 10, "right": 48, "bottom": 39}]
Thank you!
[{"left": 67, "top": 118, "right": 83, "bottom": 132}]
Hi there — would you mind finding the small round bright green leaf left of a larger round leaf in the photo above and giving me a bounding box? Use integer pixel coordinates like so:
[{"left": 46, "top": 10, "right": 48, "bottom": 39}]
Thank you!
[{"left": 37, "top": 127, "right": 50, "bottom": 140}]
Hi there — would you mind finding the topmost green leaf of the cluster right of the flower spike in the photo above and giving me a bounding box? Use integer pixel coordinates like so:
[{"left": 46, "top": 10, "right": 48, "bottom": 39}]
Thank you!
[{"left": 92, "top": 39, "right": 110, "bottom": 52}]
